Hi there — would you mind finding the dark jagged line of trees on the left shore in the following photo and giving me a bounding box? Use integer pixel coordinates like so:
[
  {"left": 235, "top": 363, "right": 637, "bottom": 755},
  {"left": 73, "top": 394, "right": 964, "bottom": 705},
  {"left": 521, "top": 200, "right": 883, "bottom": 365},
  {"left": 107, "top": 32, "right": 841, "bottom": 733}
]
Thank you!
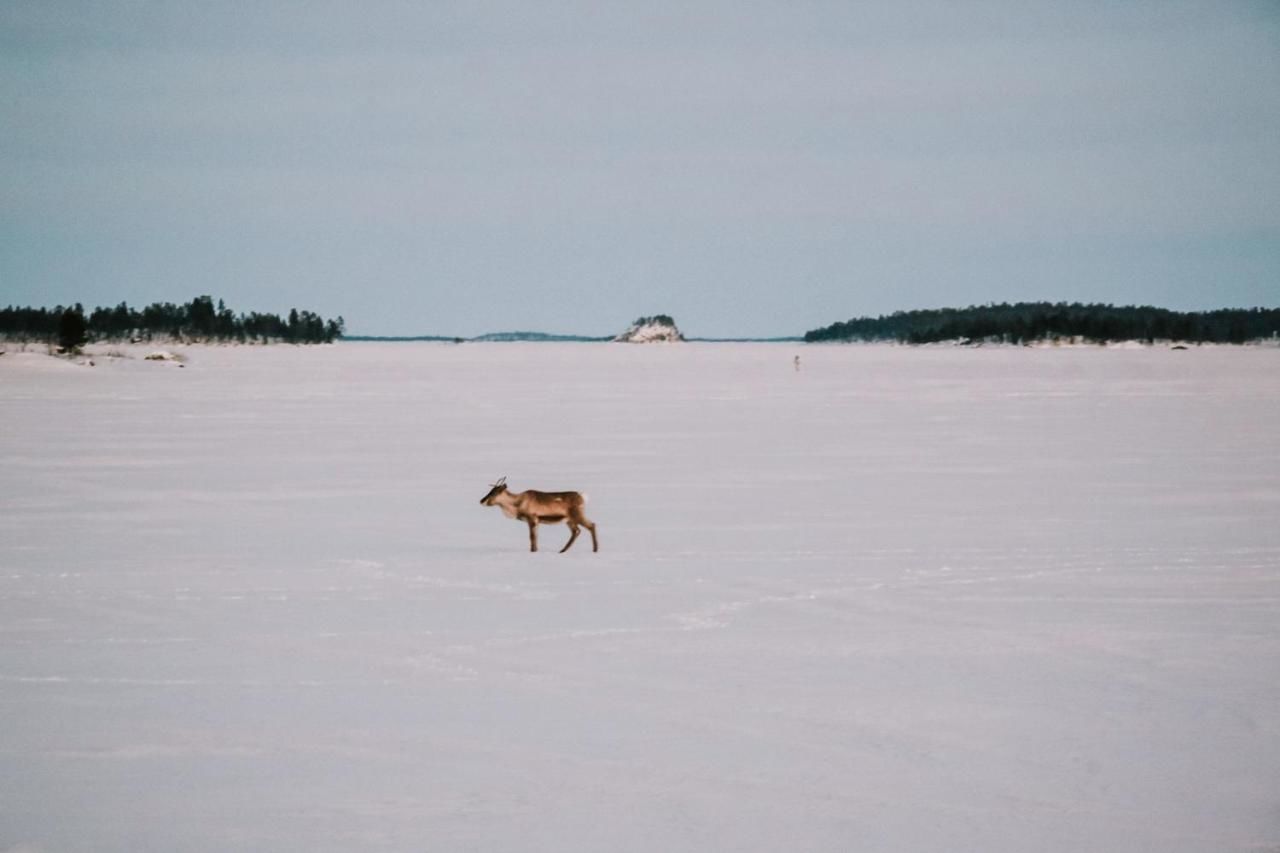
[{"left": 0, "top": 296, "right": 344, "bottom": 348}]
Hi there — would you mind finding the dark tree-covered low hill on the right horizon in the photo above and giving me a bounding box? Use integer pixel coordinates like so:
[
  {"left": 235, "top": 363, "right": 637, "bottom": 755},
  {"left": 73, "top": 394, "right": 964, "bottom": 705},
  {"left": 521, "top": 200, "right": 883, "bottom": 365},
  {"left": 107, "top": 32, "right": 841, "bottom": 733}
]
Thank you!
[{"left": 804, "top": 302, "right": 1280, "bottom": 343}]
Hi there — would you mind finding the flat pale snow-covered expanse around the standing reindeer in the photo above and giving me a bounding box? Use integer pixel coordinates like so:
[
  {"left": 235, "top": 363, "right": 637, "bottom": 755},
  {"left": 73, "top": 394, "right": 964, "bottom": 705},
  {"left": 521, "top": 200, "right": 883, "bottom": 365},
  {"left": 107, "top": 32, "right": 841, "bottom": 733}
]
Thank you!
[{"left": 0, "top": 343, "right": 1280, "bottom": 853}]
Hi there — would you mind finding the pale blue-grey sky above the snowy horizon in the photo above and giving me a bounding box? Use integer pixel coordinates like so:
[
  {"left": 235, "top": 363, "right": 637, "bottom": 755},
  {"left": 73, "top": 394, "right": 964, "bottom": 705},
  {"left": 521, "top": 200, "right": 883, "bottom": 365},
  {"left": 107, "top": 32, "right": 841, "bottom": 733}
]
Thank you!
[{"left": 0, "top": 0, "right": 1280, "bottom": 336}]
